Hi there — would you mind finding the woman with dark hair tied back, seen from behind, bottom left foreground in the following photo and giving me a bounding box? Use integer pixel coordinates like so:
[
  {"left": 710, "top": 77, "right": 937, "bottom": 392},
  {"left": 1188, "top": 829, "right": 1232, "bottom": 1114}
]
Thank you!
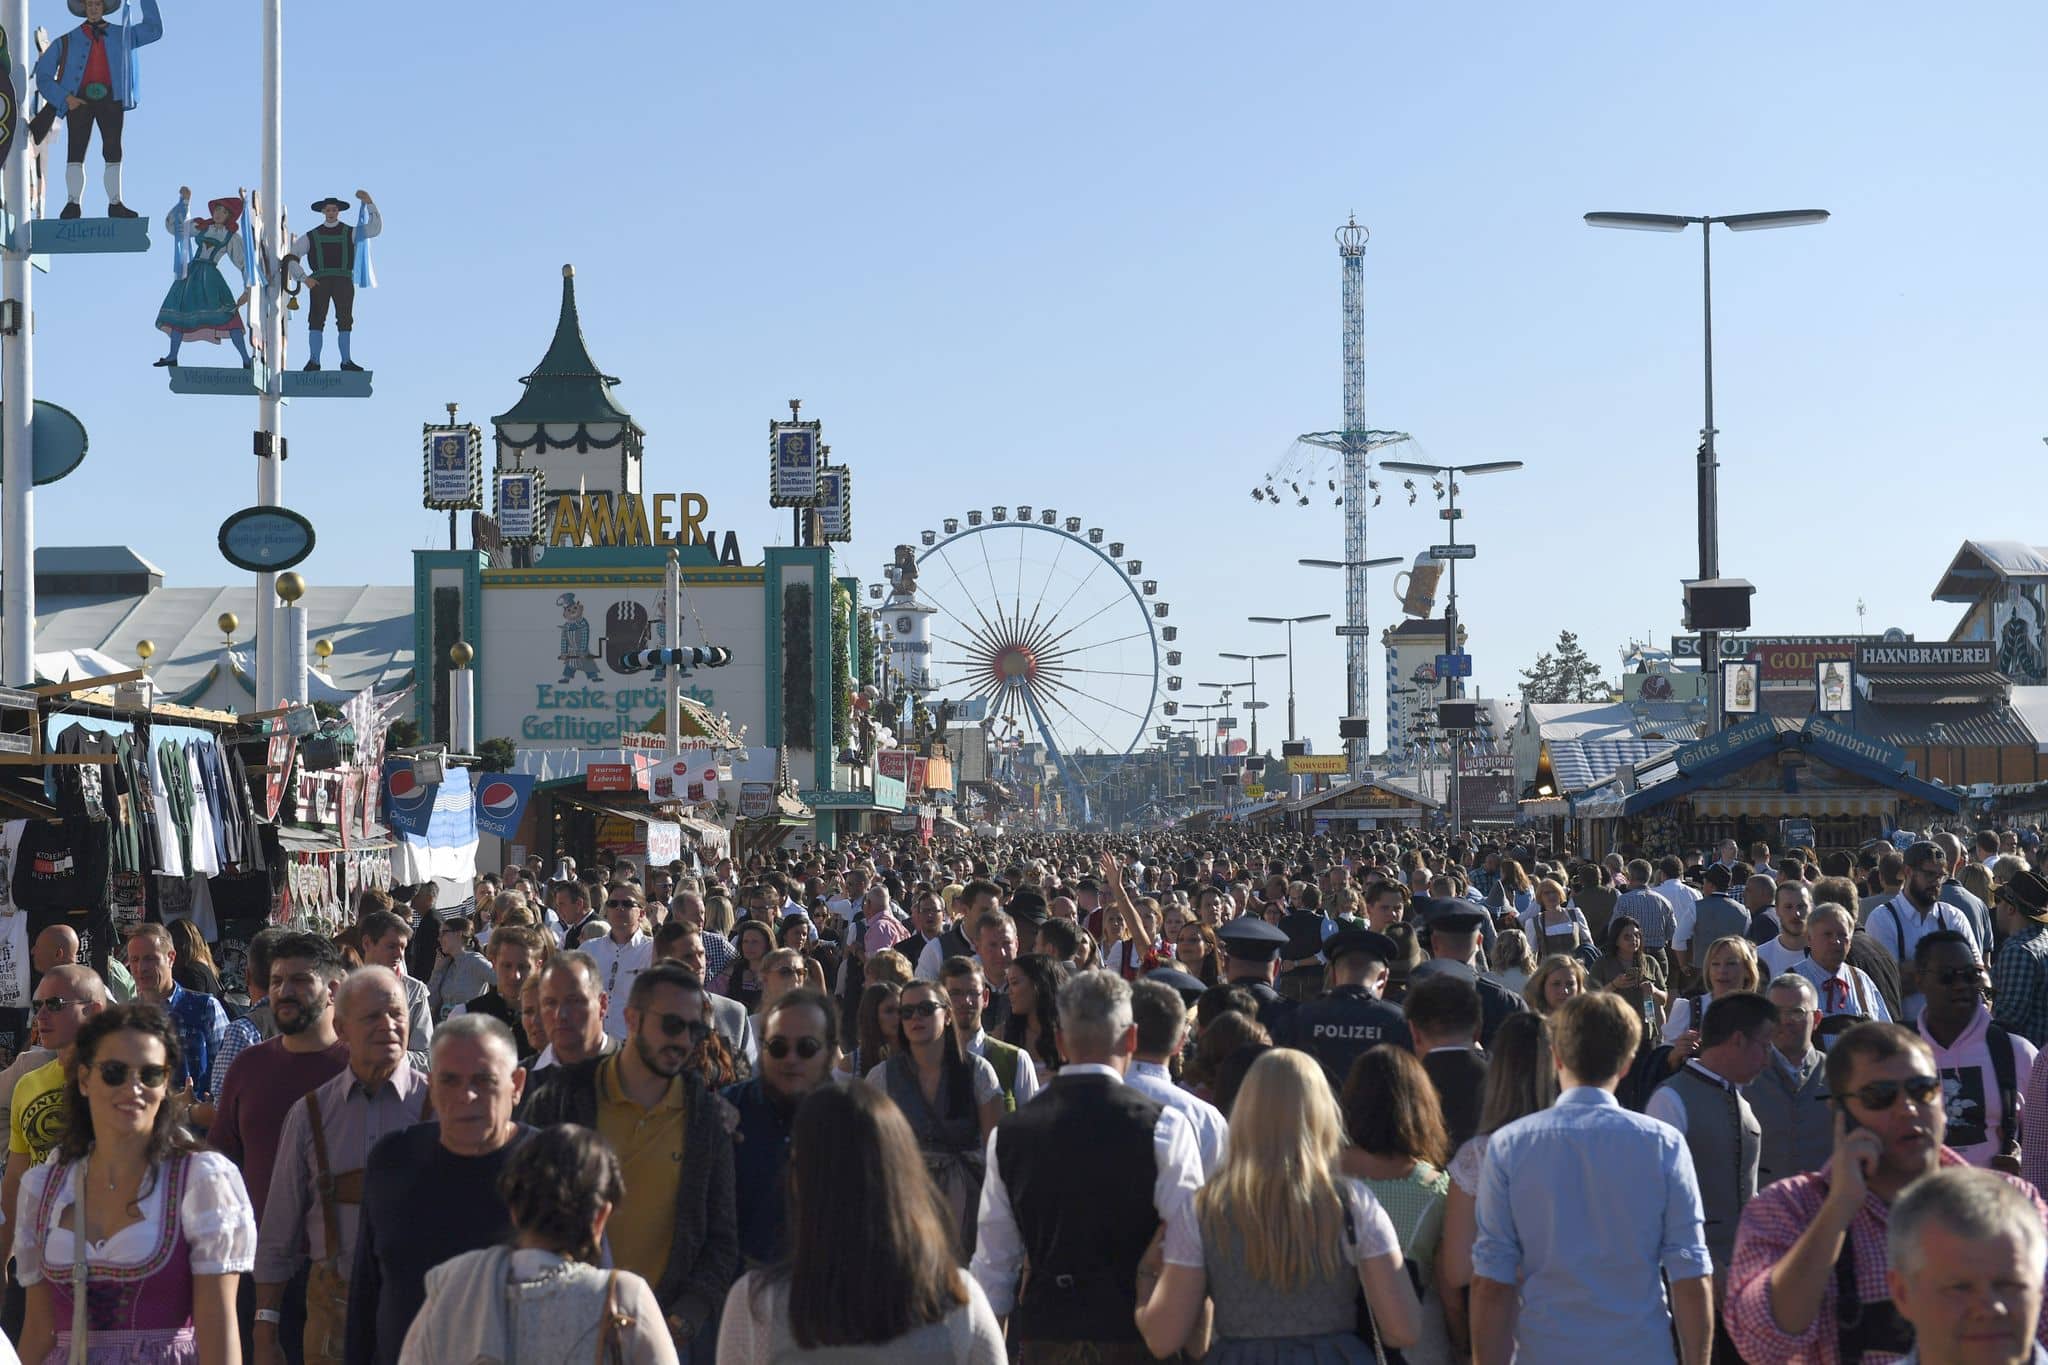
[{"left": 397, "top": 1124, "right": 676, "bottom": 1365}]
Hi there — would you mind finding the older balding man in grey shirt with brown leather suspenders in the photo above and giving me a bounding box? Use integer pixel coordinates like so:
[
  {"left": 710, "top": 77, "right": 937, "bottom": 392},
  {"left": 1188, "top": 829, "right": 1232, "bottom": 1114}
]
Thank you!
[{"left": 252, "top": 966, "right": 426, "bottom": 1365}]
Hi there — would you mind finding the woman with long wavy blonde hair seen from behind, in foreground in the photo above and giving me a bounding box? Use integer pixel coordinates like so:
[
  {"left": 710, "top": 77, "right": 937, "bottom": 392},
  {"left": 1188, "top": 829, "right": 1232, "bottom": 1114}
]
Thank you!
[{"left": 1137, "top": 1048, "right": 1421, "bottom": 1365}]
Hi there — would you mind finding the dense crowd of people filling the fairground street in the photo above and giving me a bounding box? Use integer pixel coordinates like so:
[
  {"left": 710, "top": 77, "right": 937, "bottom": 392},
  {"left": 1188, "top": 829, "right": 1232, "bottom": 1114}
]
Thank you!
[{"left": 0, "top": 831, "right": 2048, "bottom": 1365}]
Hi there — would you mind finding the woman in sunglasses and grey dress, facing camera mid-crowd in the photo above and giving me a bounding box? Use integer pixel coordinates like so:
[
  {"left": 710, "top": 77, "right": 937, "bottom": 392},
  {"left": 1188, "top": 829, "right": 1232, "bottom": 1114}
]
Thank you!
[{"left": 868, "top": 980, "right": 1004, "bottom": 1265}]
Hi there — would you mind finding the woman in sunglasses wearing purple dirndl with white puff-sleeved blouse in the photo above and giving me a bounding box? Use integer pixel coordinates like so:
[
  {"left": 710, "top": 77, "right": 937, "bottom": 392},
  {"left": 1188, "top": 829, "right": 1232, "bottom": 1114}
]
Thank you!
[{"left": 14, "top": 1005, "right": 256, "bottom": 1365}]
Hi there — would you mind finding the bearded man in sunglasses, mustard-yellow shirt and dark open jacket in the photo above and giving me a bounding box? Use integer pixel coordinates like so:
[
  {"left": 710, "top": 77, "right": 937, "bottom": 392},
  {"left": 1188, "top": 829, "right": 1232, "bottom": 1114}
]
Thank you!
[{"left": 522, "top": 954, "right": 739, "bottom": 1353}]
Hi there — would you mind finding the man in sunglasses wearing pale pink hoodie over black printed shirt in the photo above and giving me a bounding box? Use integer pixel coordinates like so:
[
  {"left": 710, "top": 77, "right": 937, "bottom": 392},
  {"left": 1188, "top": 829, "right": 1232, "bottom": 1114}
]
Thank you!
[{"left": 1913, "top": 929, "right": 2034, "bottom": 1175}]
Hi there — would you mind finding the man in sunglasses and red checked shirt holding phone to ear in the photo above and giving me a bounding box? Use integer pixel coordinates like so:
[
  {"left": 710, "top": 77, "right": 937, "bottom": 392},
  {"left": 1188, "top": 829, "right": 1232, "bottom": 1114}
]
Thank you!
[{"left": 1726, "top": 1023, "right": 2048, "bottom": 1365}]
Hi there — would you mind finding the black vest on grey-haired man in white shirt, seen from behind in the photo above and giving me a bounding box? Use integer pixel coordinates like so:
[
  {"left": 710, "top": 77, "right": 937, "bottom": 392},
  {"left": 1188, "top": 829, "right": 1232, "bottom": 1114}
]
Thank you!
[{"left": 995, "top": 1076, "right": 1159, "bottom": 1342}]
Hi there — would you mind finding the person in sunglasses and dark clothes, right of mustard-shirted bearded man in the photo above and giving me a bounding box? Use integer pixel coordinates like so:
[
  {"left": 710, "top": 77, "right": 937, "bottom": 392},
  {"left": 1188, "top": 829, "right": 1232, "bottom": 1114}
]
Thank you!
[{"left": 725, "top": 988, "right": 840, "bottom": 1269}]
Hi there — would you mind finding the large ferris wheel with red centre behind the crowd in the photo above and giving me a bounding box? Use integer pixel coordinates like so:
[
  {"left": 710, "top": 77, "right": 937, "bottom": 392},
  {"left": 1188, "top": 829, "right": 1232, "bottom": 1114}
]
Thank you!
[{"left": 888, "top": 505, "right": 1182, "bottom": 821}]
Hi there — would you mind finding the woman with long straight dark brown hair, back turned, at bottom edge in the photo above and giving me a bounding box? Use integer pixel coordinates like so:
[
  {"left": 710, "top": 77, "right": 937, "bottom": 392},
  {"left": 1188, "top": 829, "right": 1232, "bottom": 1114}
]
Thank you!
[{"left": 719, "top": 1085, "right": 1004, "bottom": 1365}]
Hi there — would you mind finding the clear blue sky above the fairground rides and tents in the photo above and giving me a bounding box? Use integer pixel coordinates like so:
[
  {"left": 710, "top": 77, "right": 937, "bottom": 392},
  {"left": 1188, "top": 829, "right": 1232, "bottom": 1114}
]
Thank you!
[{"left": 19, "top": 0, "right": 2048, "bottom": 749}]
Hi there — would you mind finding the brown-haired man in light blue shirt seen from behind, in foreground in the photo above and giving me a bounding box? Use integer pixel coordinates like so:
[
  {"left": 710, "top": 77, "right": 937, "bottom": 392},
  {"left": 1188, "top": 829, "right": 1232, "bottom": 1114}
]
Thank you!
[{"left": 1473, "top": 990, "right": 1714, "bottom": 1365}]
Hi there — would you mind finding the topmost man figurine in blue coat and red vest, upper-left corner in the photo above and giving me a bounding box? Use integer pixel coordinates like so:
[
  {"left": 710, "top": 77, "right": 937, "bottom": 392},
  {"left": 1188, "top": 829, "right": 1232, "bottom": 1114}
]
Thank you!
[{"left": 35, "top": 0, "right": 164, "bottom": 219}]
